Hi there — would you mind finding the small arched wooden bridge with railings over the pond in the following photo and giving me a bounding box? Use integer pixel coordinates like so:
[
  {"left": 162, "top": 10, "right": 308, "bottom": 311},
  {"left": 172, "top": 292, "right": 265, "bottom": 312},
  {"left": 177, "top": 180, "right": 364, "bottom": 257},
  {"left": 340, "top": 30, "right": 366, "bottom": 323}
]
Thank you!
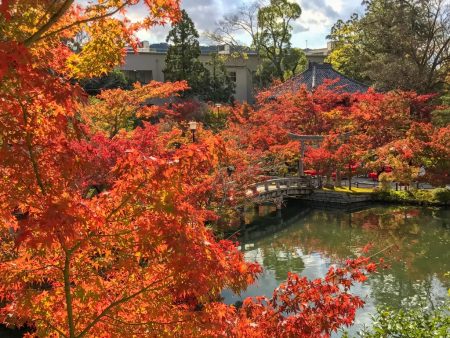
[{"left": 246, "top": 176, "right": 314, "bottom": 207}]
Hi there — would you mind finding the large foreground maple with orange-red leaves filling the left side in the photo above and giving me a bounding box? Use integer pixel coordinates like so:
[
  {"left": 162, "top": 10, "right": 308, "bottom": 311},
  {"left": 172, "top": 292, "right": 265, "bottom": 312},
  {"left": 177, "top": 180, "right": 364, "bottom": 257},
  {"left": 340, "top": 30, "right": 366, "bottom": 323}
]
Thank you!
[{"left": 0, "top": 0, "right": 388, "bottom": 338}]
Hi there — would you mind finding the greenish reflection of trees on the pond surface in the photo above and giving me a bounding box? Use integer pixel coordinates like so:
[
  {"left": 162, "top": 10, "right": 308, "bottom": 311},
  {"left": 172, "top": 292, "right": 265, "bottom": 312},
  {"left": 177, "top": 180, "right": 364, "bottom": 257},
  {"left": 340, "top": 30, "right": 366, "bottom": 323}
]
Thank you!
[{"left": 244, "top": 207, "right": 450, "bottom": 305}]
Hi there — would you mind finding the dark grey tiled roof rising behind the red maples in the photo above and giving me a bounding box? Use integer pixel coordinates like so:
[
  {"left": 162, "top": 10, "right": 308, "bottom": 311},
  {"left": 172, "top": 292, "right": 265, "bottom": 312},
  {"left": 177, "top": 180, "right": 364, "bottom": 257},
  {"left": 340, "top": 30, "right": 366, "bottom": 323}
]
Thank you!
[{"left": 273, "top": 62, "right": 369, "bottom": 96}]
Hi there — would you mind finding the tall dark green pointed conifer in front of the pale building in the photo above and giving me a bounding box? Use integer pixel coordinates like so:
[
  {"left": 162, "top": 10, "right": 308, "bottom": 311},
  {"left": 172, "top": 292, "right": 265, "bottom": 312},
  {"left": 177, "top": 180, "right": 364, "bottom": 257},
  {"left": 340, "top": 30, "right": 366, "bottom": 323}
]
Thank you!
[{"left": 163, "top": 10, "right": 210, "bottom": 97}]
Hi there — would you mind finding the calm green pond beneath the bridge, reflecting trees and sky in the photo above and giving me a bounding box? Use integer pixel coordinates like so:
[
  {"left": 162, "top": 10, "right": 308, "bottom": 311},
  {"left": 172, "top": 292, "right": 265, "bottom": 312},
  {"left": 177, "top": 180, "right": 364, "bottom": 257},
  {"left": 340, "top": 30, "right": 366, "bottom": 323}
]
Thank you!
[{"left": 223, "top": 201, "right": 450, "bottom": 333}]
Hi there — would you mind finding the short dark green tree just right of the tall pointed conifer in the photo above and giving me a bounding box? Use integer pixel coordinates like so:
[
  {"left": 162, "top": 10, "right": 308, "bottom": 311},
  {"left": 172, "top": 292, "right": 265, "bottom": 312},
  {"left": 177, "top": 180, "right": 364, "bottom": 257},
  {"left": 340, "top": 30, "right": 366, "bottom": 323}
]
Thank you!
[{"left": 205, "top": 53, "right": 236, "bottom": 103}]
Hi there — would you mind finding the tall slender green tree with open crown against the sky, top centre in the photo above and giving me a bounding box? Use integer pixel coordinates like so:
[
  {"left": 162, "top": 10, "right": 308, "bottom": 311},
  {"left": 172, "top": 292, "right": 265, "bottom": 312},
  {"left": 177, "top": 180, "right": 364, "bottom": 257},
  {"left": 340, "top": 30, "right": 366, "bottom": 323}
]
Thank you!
[{"left": 257, "top": 0, "right": 302, "bottom": 81}]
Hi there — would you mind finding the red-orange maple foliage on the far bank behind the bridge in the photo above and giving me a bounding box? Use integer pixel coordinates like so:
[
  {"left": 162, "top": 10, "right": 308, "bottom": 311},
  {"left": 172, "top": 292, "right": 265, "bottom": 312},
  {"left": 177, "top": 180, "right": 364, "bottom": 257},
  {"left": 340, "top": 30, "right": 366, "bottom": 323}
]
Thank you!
[{"left": 229, "top": 79, "right": 450, "bottom": 186}]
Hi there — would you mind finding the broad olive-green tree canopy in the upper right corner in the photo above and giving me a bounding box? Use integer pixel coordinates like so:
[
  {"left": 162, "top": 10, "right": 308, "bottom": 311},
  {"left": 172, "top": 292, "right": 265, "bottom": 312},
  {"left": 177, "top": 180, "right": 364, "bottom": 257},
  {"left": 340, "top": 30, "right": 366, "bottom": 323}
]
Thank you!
[{"left": 329, "top": 0, "right": 450, "bottom": 92}]
